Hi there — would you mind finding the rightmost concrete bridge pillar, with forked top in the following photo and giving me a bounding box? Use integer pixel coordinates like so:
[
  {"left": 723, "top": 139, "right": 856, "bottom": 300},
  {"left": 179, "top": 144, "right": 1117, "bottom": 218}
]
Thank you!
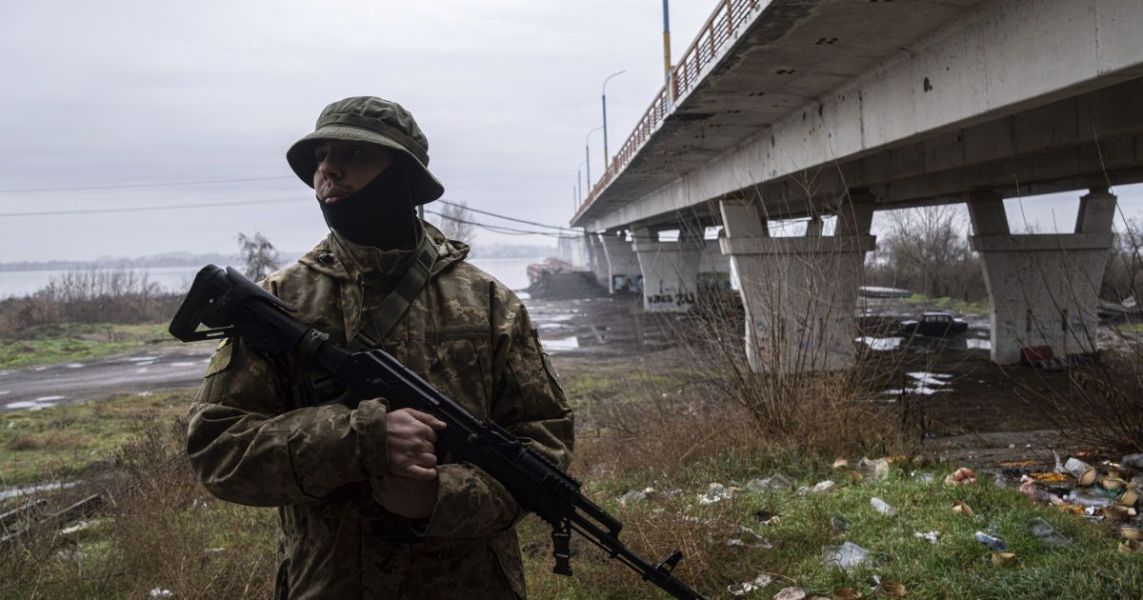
[{"left": 968, "top": 187, "right": 1116, "bottom": 365}]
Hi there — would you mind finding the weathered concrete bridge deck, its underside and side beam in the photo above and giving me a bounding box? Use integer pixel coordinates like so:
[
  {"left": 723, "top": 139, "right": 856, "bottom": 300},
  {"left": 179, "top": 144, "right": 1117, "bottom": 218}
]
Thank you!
[{"left": 573, "top": 0, "right": 1143, "bottom": 231}]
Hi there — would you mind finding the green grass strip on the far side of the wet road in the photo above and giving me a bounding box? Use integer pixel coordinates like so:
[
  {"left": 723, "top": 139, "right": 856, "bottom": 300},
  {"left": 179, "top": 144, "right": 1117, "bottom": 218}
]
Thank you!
[{"left": 0, "top": 323, "right": 174, "bottom": 369}]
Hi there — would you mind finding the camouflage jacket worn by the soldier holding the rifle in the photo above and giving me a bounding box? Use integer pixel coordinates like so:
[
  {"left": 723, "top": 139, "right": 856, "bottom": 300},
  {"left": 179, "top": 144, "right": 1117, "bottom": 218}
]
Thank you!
[{"left": 187, "top": 225, "right": 573, "bottom": 599}]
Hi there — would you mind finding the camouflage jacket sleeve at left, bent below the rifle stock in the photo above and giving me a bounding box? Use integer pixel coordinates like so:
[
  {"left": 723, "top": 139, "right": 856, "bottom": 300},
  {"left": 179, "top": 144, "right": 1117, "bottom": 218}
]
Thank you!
[{"left": 186, "top": 341, "right": 387, "bottom": 506}]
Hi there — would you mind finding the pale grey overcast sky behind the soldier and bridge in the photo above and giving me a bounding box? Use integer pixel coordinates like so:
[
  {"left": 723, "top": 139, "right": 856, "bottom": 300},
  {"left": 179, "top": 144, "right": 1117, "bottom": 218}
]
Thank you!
[{"left": 0, "top": 0, "right": 1138, "bottom": 262}]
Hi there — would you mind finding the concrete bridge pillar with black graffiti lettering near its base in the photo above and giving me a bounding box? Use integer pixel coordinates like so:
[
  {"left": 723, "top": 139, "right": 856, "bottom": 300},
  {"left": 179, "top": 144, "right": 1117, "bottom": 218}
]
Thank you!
[{"left": 633, "top": 225, "right": 703, "bottom": 312}]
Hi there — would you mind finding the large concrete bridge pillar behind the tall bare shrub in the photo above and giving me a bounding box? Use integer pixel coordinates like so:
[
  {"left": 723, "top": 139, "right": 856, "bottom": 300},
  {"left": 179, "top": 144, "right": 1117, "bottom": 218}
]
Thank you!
[{"left": 721, "top": 194, "right": 876, "bottom": 373}]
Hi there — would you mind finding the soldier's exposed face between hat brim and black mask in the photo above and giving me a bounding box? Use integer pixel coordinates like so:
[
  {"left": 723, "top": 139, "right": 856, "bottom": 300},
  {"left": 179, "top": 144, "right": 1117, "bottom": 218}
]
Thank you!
[{"left": 313, "top": 141, "right": 393, "bottom": 205}]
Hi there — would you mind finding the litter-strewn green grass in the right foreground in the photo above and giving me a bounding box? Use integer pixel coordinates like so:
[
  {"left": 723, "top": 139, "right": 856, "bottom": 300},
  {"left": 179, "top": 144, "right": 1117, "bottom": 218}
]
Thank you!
[{"left": 523, "top": 454, "right": 1143, "bottom": 599}]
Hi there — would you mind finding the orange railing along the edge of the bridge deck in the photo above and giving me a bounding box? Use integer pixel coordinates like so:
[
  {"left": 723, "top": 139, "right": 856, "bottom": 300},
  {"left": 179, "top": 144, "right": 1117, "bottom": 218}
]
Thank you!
[{"left": 576, "top": 0, "right": 760, "bottom": 218}]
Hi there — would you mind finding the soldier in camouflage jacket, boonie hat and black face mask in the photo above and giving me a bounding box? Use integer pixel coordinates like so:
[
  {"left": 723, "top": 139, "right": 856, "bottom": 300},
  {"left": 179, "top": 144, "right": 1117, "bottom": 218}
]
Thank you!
[{"left": 187, "top": 97, "right": 573, "bottom": 599}]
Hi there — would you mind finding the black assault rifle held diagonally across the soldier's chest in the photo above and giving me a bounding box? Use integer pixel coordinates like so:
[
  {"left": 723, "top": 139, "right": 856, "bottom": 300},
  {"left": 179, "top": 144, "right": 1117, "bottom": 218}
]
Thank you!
[{"left": 170, "top": 265, "right": 703, "bottom": 600}]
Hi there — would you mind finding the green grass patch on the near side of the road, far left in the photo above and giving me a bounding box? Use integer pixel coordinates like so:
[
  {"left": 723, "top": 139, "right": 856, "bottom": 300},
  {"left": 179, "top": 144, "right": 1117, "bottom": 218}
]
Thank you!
[{"left": 0, "top": 390, "right": 193, "bottom": 486}]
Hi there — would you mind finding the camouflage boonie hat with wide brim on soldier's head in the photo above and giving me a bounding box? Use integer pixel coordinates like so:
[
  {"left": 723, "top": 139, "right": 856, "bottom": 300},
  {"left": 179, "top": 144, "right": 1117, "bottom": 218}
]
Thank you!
[{"left": 286, "top": 96, "right": 445, "bottom": 205}]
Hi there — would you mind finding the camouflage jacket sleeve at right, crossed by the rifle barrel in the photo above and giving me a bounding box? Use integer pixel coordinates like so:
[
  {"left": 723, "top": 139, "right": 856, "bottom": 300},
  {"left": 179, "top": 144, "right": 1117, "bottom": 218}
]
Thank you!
[{"left": 424, "top": 296, "right": 574, "bottom": 537}]
